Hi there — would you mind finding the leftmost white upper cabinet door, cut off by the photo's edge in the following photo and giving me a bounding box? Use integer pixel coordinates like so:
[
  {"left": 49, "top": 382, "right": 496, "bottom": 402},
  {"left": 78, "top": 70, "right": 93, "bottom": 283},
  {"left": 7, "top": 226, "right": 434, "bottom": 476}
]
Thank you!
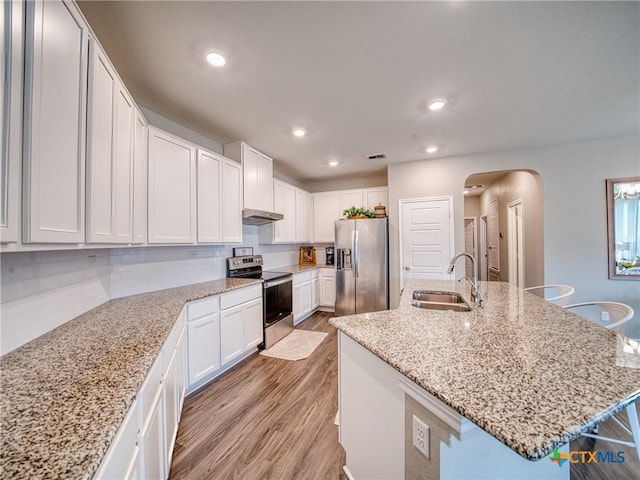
[{"left": 0, "top": 0, "right": 24, "bottom": 243}]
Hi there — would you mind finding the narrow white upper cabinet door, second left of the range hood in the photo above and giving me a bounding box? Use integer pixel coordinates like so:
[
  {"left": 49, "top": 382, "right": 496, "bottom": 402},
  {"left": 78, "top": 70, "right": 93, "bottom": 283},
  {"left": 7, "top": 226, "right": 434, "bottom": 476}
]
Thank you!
[{"left": 198, "top": 149, "right": 224, "bottom": 242}]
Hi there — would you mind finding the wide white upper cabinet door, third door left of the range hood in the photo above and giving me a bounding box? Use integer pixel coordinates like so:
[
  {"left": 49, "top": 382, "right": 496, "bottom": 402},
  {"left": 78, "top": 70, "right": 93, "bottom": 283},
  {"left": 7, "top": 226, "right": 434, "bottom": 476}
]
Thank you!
[{"left": 148, "top": 127, "right": 196, "bottom": 243}]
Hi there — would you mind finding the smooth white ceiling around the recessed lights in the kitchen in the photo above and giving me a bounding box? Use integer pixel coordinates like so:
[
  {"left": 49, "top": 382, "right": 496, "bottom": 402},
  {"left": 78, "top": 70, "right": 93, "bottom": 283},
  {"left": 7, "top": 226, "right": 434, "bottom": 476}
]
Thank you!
[{"left": 79, "top": 1, "right": 640, "bottom": 182}]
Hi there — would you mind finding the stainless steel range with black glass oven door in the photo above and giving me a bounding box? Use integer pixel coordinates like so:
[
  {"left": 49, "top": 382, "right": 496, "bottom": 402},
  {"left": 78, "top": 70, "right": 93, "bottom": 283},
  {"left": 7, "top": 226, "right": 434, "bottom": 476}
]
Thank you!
[{"left": 227, "top": 255, "right": 293, "bottom": 349}]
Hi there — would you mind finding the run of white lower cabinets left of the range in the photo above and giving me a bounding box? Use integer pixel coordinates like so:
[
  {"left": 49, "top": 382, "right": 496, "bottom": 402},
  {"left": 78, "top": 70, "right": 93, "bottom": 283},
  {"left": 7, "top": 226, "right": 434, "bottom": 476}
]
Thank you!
[{"left": 94, "top": 284, "right": 263, "bottom": 480}]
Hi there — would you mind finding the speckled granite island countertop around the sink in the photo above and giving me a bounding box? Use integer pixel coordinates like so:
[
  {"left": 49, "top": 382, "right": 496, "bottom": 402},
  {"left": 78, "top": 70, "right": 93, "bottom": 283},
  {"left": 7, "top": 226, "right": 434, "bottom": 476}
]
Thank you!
[{"left": 330, "top": 280, "right": 640, "bottom": 460}]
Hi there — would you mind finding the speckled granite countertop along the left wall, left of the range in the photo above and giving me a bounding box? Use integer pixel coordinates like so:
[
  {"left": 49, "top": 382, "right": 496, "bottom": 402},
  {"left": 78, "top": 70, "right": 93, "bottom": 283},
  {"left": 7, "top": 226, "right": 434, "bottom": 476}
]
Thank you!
[{"left": 0, "top": 279, "right": 261, "bottom": 479}]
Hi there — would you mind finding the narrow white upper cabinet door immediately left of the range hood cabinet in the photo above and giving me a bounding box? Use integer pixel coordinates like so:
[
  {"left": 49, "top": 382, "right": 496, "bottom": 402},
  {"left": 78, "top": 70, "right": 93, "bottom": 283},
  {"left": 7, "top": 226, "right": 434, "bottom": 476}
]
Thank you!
[{"left": 222, "top": 158, "right": 242, "bottom": 243}]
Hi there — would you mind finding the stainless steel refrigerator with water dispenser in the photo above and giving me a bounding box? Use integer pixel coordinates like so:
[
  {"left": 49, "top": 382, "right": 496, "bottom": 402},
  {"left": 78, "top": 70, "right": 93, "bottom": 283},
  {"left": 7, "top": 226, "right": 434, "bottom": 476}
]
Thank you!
[{"left": 335, "top": 218, "right": 389, "bottom": 315}]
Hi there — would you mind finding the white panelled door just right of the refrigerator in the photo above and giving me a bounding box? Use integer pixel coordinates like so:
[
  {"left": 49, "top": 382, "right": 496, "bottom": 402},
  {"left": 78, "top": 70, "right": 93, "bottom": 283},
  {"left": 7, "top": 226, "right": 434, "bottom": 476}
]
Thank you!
[{"left": 400, "top": 197, "right": 453, "bottom": 287}]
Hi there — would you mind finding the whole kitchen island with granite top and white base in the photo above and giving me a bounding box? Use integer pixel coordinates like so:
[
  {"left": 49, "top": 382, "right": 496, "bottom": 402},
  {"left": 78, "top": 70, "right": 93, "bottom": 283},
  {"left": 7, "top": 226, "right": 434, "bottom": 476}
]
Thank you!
[{"left": 331, "top": 280, "right": 640, "bottom": 479}]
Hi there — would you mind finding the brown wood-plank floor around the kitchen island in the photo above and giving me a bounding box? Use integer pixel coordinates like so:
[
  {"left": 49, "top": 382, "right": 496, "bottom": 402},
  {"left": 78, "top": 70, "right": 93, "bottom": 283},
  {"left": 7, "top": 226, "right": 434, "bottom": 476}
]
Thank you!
[{"left": 169, "top": 312, "right": 640, "bottom": 480}]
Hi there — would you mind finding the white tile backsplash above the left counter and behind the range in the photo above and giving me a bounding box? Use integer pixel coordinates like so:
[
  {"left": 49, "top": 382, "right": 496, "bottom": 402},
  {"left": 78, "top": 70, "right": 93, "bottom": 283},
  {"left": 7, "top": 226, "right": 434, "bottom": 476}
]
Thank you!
[{"left": 0, "top": 226, "right": 302, "bottom": 354}]
